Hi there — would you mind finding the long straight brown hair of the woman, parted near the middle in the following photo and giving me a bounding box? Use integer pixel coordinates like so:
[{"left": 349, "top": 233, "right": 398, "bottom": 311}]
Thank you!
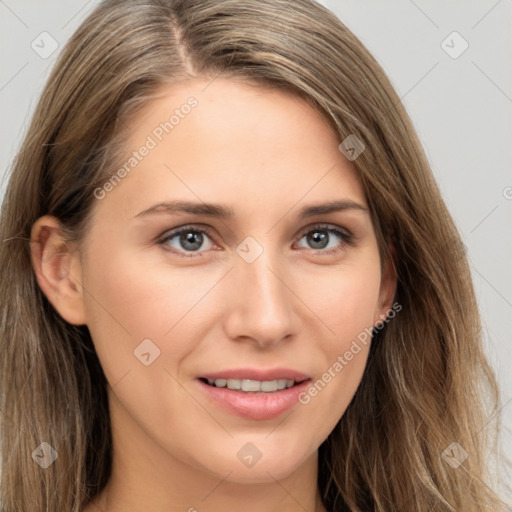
[{"left": 0, "top": 0, "right": 508, "bottom": 512}]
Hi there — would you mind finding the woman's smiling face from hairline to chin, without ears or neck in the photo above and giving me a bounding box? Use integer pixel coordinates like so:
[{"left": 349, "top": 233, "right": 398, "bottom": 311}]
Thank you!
[{"left": 65, "top": 78, "right": 392, "bottom": 483}]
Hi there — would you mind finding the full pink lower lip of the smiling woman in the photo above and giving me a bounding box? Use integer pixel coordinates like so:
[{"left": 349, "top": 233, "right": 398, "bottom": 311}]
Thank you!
[{"left": 197, "top": 379, "right": 311, "bottom": 420}]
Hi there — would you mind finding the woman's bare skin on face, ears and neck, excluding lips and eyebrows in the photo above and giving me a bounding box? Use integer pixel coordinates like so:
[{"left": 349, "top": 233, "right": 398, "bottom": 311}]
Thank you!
[{"left": 31, "top": 78, "right": 396, "bottom": 512}]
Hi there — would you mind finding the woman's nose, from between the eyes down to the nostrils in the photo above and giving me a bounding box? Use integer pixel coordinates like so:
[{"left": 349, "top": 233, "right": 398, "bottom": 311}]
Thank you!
[{"left": 224, "top": 245, "right": 298, "bottom": 348}]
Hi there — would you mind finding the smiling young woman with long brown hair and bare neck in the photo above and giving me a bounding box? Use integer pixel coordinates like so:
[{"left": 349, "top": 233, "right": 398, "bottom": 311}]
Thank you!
[{"left": 0, "top": 0, "right": 504, "bottom": 512}]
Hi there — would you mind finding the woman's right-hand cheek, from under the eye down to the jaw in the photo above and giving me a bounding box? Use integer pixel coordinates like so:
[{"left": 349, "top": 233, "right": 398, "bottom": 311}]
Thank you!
[{"left": 299, "top": 258, "right": 380, "bottom": 424}]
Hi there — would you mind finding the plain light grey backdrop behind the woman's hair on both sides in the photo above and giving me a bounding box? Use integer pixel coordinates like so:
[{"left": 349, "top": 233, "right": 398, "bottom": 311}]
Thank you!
[{"left": 0, "top": 0, "right": 512, "bottom": 504}]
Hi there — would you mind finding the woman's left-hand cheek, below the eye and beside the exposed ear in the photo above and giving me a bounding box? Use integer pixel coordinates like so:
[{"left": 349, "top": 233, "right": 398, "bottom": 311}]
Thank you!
[{"left": 80, "top": 244, "right": 219, "bottom": 380}]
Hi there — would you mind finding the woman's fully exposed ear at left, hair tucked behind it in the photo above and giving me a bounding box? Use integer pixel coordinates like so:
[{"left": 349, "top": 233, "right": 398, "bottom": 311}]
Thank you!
[{"left": 30, "top": 215, "right": 86, "bottom": 325}]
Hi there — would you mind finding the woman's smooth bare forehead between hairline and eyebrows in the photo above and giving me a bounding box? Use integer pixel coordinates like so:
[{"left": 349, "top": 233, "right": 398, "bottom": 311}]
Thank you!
[{"left": 93, "top": 78, "right": 365, "bottom": 222}]
